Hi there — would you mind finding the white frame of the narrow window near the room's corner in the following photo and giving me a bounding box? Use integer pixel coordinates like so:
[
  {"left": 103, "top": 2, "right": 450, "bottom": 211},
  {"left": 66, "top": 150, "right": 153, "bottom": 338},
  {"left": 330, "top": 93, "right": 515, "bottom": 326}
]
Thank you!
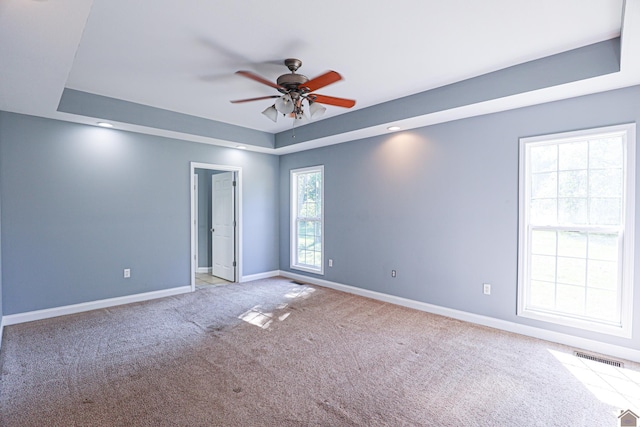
[{"left": 289, "top": 165, "right": 325, "bottom": 275}]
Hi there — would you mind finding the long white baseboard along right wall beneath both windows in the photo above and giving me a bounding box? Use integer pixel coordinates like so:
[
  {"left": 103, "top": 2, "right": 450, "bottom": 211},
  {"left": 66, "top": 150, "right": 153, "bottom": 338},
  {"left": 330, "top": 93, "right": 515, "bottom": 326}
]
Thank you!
[{"left": 280, "top": 270, "right": 640, "bottom": 362}]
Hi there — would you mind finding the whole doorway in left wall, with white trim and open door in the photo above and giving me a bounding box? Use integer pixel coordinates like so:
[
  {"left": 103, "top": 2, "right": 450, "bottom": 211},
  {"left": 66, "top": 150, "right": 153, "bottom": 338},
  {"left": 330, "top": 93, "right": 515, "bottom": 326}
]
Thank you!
[{"left": 190, "top": 162, "right": 242, "bottom": 291}]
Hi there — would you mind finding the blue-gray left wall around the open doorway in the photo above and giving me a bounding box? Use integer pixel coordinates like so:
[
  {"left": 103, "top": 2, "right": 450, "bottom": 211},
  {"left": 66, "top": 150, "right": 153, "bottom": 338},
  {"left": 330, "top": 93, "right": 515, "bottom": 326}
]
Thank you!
[{"left": 0, "top": 112, "right": 279, "bottom": 315}]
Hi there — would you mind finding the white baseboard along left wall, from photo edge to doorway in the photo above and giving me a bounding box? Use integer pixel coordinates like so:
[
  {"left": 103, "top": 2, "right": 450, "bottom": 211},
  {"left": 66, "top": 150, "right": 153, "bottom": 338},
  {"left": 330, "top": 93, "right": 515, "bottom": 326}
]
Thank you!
[{"left": 2, "top": 286, "right": 191, "bottom": 326}]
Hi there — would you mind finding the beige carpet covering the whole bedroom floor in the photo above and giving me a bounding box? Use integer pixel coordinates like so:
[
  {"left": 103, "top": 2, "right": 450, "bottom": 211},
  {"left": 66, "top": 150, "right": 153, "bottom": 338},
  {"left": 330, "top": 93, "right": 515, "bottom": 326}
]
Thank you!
[{"left": 0, "top": 279, "right": 640, "bottom": 427}]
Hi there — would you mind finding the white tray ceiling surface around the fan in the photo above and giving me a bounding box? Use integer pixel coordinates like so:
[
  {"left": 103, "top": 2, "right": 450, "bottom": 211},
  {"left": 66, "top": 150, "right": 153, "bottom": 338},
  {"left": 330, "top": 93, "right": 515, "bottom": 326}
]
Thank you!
[{"left": 0, "top": 0, "right": 640, "bottom": 150}]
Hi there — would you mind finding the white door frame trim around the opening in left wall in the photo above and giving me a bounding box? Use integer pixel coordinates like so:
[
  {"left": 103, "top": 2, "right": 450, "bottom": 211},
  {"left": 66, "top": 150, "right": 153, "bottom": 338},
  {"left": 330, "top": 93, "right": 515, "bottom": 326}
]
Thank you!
[{"left": 189, "top": 162, "right": 243, "bottom": 292}]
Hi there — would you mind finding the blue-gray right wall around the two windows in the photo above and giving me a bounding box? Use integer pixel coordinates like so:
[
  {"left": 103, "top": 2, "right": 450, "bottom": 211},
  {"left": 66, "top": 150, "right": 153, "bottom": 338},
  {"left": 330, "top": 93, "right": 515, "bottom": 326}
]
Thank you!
[{"left": 280, "top": 87, "right": 640, "bottom": 349}]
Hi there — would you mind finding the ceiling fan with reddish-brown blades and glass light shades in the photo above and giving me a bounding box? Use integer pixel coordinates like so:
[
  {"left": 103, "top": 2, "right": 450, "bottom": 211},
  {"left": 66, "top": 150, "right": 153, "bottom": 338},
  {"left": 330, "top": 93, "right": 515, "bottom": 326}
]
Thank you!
[{"left": 231, "top": 58, "right": 356, "bottom": 122}]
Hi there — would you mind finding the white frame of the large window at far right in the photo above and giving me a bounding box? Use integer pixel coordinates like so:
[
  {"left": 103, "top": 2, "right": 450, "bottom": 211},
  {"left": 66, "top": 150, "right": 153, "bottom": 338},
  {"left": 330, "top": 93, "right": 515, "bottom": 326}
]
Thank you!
[{"left": 517, "top": 123, "right": 636, "bottom": 338}]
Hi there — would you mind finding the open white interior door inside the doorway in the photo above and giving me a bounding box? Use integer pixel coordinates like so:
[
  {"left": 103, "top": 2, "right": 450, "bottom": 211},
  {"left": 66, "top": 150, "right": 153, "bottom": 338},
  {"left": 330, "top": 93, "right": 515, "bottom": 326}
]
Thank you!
[{"left": 211, "top": 172, "right": 235, "bottom": 282}]
